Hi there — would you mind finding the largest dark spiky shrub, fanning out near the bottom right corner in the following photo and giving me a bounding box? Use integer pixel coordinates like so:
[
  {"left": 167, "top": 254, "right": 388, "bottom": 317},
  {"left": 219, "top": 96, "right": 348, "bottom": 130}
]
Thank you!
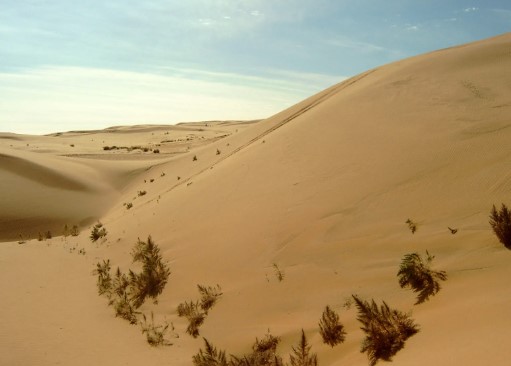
[{"left": 353, "top": 295, "right": 419, "bottom": 366}]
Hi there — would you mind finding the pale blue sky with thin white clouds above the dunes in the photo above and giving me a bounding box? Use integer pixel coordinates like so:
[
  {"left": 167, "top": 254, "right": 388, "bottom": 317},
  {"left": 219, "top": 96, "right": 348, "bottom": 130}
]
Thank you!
[{"left": 0, "top": 0, "right": 511, "bottom": 134}]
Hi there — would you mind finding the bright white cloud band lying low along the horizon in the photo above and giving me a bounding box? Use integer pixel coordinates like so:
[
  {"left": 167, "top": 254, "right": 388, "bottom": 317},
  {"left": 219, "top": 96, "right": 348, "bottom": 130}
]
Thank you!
[{"left": 0, "top": 67, "right": 340, "bottom": 133}]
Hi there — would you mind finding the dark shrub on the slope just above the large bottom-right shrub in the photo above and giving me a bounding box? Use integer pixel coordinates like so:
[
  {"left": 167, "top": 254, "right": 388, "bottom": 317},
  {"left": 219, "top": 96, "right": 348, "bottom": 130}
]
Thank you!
[{"left": 397, "top": 251, "right": 447, "bottom": 304}]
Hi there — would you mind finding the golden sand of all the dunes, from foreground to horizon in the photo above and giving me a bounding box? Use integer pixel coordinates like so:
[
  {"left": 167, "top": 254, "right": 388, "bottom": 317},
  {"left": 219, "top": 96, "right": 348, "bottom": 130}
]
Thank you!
[{"left": 0, "top": 34, "right": 511, "bottom": 365}]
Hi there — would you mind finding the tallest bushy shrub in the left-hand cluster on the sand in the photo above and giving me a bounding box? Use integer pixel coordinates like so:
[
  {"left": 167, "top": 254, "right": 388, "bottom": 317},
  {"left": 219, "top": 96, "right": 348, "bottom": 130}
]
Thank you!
[{"left": 130, "top": 236, "right": 170, "bottom": 308}]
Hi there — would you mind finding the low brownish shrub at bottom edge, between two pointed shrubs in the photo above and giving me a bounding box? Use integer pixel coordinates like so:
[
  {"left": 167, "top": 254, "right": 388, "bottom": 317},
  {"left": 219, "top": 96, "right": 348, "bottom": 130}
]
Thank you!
[{"left": 231, "top": 334, "right": 284, "bottom": 366}]
